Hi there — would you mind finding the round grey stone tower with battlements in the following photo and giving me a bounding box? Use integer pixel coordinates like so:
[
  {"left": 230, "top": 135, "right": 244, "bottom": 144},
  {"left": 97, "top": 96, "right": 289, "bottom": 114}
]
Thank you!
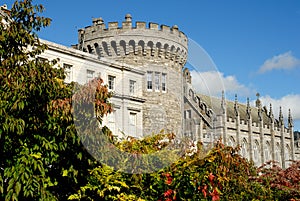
[{"left": 77, "top": 14, "right": 188, "bottom": 135}]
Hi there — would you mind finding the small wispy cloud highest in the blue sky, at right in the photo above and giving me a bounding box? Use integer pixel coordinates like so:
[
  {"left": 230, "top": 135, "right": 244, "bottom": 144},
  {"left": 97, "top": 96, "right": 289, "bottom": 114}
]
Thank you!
[{"left": 258, "top": 51, "right": 300, "bottom": 73}]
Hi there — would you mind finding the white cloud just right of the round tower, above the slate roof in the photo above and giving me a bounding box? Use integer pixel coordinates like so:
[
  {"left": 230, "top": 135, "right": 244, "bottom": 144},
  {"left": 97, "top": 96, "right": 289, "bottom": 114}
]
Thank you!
[{"left": 191, "top": 70, "right": 250, "bottom": 96}]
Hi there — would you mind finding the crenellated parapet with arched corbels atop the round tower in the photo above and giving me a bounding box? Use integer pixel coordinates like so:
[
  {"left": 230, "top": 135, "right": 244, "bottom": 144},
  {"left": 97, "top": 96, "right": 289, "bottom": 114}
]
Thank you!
[{"left": 77, "top": 14, "right": 188, "bottom": 66}]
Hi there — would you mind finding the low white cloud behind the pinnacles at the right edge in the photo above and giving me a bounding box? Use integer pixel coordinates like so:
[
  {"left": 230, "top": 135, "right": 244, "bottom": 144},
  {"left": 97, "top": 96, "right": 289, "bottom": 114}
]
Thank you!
[{"left": 260, "top": 94, "right": 300, "bottom": 120}]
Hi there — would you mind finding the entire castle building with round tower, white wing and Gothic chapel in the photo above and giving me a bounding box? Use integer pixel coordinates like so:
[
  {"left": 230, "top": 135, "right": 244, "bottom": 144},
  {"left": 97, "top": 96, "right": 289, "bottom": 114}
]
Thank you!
[{"left": 1, "top": 4, "right": 300, "bottom": 168}]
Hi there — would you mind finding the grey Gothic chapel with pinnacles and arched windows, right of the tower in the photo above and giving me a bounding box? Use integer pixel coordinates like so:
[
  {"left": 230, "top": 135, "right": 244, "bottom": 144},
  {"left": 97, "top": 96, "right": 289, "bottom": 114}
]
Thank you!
[{"left": 183, "top": 69, "right": 299, "bottom": 168}]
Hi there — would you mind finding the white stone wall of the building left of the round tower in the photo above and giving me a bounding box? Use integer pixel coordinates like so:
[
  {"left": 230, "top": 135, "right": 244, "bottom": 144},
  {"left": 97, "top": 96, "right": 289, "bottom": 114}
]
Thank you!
[{"left": 40, "top": 40, "right": 144, "bottom": 137}]
